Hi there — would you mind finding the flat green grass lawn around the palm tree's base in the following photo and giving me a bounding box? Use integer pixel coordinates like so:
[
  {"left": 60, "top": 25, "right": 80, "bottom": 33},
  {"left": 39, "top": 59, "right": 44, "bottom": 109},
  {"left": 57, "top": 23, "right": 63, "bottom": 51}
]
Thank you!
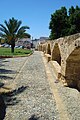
[{"left": 0, "top": 47, "right": 32, "bottom": 56}]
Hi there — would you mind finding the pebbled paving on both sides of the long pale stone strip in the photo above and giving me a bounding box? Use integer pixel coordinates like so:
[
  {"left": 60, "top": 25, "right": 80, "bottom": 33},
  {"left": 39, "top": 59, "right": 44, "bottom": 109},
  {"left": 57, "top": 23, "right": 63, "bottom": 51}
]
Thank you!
[{"left": 0, "top": 52, "right": 80, "bottom": 120}]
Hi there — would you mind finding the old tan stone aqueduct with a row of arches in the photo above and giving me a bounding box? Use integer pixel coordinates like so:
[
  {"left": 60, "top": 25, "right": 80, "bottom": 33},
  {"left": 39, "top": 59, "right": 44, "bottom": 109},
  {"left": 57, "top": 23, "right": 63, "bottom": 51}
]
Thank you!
[{"left": 38, "top": 33, "right": 80, "bottom": 90}]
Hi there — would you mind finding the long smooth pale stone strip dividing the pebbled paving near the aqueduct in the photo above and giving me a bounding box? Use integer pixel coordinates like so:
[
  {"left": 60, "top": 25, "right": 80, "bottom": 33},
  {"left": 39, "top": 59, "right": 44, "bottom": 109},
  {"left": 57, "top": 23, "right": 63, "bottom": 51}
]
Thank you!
[{"left": 41, "top": 53, "right": 70, "bottom": 120}]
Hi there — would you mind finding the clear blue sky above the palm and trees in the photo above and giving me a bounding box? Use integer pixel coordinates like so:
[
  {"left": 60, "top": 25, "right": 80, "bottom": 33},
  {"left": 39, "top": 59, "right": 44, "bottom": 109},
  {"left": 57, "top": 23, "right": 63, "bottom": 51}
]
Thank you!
[{"left": 0, "top": 0, "right": 80, "bottom": 38}]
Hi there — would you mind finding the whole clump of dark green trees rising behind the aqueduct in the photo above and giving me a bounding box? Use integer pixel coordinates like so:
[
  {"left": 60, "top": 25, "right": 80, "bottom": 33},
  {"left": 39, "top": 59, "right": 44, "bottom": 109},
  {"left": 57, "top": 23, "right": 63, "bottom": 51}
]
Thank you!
[{"left": 49, "top": 6, "right": 80, "bottom": 39}]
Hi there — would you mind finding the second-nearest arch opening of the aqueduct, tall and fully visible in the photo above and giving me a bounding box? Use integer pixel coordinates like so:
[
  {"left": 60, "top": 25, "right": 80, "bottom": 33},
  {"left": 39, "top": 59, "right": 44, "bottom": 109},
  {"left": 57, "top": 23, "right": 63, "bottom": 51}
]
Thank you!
[{"left": 52, "top": 43, "right": 61, "bottom": 65}]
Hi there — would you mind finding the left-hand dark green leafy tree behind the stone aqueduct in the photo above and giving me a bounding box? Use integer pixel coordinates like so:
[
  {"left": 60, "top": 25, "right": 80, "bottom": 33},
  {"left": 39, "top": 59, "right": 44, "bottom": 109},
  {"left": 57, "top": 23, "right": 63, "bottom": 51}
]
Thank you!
[{"left": 49, "top": 7, "right": 68, "bottom": 39}]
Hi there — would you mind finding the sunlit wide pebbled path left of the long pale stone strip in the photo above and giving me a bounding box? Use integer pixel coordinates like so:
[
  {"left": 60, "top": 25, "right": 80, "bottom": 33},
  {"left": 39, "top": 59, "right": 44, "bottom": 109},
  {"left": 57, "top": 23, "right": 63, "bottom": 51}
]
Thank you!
[{"left": 2, "top": 52, "right": 59, "bottom": 120}]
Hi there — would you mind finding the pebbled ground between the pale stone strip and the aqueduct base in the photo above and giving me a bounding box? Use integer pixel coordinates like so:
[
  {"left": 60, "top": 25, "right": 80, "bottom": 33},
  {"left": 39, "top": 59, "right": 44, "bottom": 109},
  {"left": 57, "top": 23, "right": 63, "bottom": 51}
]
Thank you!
[{"left": 48, "top": 63, "right": 80, "bottom": 120}]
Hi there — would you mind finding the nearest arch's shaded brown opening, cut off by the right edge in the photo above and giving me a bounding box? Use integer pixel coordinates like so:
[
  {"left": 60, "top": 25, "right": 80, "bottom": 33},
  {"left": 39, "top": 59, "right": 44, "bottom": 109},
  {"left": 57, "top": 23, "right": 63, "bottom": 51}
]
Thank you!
[{"left": 65, "top": 47, "right": 80, "bottom": 90}]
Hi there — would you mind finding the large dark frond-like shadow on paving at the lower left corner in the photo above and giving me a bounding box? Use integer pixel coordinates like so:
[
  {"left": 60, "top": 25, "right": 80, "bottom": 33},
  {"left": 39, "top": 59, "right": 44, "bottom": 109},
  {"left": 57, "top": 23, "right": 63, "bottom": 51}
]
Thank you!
[{"left": 0, "top": 86, "right": 28, "bottom": 120}]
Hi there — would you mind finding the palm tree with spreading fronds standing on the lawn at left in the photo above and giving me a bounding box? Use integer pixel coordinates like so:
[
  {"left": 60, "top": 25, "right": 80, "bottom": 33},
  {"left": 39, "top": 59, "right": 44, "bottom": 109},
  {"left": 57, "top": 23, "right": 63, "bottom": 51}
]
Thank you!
[{"left": 0, "top": 17, "right": 30, "bottom": 53}]
